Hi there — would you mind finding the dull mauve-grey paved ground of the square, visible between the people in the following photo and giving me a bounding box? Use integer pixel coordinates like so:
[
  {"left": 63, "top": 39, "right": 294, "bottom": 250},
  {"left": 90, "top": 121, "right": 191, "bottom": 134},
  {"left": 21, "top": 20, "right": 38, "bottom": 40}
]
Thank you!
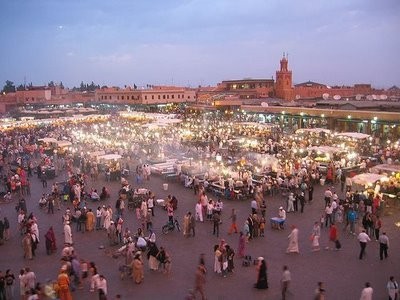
[{"left": 0, "top": 168, "right": 400, "bottom": 300}]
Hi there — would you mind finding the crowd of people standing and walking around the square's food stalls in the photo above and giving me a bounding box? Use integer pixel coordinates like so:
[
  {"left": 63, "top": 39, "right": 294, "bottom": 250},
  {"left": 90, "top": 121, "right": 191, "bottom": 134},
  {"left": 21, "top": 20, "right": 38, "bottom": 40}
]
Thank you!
[{"left": 0, "top": 110, "right": 398, "bottom": 300}]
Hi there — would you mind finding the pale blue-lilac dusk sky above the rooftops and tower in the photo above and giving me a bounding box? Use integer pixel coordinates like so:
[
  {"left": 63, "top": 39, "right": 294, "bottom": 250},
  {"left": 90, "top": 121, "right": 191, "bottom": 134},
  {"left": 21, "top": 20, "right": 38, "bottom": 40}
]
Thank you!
[{"left": 0, "top": 0, "right": 400, "bottom": 88}]
